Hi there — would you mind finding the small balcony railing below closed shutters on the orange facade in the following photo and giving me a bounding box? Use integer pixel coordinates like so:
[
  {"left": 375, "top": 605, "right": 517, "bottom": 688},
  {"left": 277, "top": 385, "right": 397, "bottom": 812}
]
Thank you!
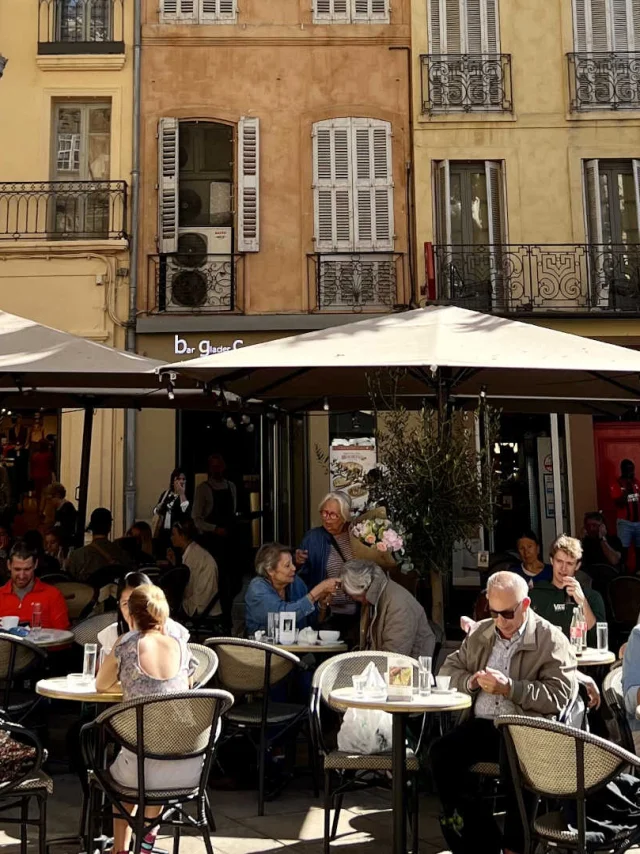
[{"left": 307, "top": 252, "right": 404, "bottom": 311}]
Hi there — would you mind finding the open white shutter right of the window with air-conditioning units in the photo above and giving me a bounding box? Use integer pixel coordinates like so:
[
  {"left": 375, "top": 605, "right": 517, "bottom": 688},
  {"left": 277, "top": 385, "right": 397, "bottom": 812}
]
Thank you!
[{"left": 237, "top": 116, "right": 260, "bottom": 252}]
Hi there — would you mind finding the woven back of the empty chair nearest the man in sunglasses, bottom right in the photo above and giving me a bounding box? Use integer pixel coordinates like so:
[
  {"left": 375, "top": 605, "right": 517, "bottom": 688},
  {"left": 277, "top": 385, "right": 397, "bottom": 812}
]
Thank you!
[{"left": 496, "top": 715, "right": 640, "bottom": 798}]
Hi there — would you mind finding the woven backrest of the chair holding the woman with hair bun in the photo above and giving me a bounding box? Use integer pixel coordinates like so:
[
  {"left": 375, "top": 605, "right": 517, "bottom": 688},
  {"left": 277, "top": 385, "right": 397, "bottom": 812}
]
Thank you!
[{"left": 96, "top": 690, "right": 233, "bottom": 759}]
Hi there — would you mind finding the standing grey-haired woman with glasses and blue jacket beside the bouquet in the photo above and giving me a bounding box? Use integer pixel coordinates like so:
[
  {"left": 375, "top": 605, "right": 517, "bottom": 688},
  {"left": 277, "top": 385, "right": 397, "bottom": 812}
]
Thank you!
[{"left": 295, "top": 492, "right": 358, "bottom": 634}]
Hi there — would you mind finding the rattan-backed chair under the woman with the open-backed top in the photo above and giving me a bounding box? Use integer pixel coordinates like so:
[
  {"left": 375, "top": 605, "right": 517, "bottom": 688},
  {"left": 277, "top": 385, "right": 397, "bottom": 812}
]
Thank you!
[{"left": 81, "top": 689, "right": 233, "bottom": 854}]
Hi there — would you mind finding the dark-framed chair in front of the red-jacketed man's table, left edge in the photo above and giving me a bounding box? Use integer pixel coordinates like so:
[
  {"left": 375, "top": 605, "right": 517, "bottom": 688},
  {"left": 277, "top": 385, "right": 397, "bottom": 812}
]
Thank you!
[{"left": 0, "top": 633, "right": 48, "bottom": 722}]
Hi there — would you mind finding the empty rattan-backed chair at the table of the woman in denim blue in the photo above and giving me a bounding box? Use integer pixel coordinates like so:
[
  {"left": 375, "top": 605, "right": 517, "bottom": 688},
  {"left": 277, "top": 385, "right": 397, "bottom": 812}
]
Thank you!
[{"left": 205, "top": 638, "right": 317, "bottom": 815}]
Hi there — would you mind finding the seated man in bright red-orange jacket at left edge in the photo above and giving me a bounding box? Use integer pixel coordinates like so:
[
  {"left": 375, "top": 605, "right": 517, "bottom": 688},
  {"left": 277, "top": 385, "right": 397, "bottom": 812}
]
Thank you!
[{"left": 0, "top": 540, "right": 69, "bottom": 629}]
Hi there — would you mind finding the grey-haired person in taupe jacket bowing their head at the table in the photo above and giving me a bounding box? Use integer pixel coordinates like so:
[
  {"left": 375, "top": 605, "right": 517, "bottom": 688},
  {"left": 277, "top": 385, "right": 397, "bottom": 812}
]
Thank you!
[{"left": 341, "top": 560, "right": 436, "bottom": 658}]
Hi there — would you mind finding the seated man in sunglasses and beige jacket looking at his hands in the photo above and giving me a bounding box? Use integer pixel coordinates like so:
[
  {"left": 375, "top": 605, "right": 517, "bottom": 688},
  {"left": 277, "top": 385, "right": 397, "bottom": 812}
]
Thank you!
[{"left": 430, "top": 571, "right": 578, "bottom": 854}]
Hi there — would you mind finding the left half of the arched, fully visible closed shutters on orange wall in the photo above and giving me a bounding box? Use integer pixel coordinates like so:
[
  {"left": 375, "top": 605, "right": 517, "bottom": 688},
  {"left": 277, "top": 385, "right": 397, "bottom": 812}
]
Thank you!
[{"left": 313, "top": 119, "right": 354, "bottom": 252}]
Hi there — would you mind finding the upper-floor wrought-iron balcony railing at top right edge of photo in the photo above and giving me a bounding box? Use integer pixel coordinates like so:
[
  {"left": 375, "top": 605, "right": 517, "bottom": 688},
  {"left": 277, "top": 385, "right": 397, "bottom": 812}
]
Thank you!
[{"left": 568, "top": 51, "right": 640, "bottom": 113}]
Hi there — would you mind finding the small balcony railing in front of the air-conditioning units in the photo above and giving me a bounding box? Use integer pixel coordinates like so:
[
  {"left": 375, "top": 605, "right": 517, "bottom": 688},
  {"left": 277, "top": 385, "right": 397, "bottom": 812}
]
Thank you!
[{"left": 149, "top": 252, "right": 244, "bottom": 314}]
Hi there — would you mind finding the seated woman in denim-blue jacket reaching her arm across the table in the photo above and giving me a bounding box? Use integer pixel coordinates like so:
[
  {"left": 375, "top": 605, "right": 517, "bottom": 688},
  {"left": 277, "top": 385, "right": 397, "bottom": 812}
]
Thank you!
[{"left": 244, "top": 543, "right": 339, "bottom": 635}]
